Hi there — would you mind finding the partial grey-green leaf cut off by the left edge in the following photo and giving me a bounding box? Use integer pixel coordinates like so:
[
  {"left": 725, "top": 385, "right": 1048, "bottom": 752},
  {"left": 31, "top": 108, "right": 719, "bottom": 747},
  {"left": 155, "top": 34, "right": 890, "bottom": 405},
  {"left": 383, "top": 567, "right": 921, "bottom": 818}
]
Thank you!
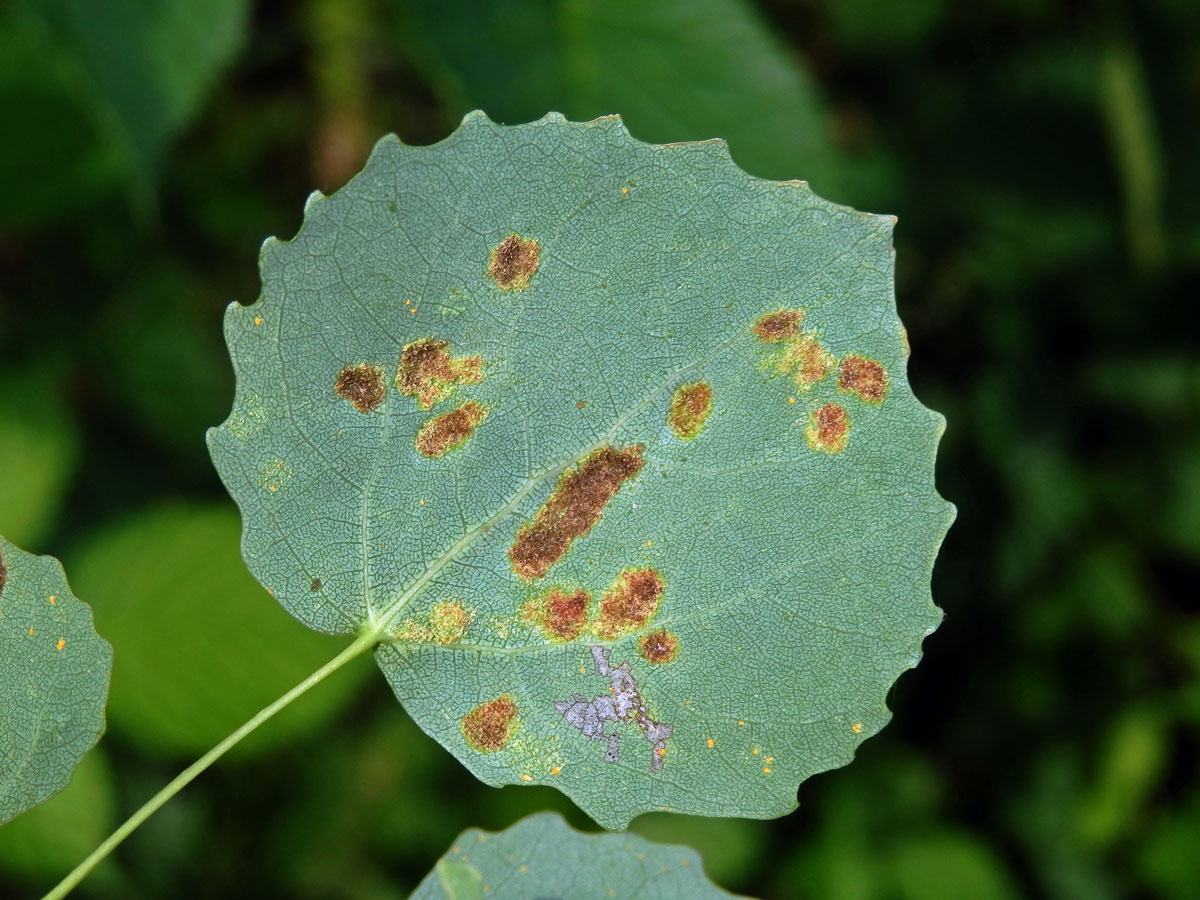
[{"left": 0, "top": 538, "right": 113, "bottom": 824}]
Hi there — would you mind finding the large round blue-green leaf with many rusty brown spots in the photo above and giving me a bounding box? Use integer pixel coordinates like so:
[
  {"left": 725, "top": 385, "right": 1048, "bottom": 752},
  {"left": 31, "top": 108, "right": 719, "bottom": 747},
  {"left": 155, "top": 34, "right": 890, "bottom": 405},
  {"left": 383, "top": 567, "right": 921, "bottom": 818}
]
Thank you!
[{"left": 209, "top": 114, "right": 953, "bottom": 828}]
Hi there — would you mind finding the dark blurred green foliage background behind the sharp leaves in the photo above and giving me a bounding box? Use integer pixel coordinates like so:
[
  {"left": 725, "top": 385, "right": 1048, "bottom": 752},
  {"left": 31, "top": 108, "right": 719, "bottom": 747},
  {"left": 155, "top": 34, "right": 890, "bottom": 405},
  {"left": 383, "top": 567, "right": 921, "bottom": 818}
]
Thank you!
[{"left": 0, "top": 0, "right": 1200, "bottom": 900}]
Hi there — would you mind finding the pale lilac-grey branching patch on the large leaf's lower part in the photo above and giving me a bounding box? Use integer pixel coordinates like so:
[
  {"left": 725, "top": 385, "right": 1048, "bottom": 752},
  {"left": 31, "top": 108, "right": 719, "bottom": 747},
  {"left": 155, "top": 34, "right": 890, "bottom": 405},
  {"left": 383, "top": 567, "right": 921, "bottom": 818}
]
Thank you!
[{"left": 554, "top": 647, "right": 674, "bottom": 772}]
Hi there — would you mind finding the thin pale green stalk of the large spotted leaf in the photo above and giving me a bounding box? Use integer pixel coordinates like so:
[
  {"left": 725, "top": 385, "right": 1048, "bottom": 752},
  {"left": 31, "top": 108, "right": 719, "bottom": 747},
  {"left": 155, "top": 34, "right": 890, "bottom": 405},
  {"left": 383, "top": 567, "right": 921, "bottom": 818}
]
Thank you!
[{"left": 42, "top": 628, "right": 379, "bottom": 900}]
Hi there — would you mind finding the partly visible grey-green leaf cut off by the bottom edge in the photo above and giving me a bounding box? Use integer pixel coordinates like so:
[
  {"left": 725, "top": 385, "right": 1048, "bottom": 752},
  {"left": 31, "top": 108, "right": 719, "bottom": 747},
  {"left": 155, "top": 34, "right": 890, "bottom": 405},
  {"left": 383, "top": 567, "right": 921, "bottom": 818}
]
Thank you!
[{"left": 410, "top": 812, "right": 748, "bottom": 900}]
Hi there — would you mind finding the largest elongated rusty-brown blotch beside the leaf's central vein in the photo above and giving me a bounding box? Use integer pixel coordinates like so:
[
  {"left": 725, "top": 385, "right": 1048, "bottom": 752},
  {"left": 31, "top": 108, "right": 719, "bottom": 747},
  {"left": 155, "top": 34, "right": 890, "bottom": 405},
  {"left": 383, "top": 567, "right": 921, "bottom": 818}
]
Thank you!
[{"left": 509, "top": 446, "right": 644, "bottom": 581}]
